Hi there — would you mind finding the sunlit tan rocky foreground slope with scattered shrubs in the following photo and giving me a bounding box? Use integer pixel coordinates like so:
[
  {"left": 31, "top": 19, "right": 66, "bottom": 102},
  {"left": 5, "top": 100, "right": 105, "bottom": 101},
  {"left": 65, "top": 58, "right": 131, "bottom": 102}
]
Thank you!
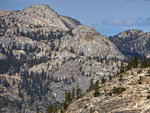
[{"left": 66, "top": 68, "right": 150, "bottom": 113}]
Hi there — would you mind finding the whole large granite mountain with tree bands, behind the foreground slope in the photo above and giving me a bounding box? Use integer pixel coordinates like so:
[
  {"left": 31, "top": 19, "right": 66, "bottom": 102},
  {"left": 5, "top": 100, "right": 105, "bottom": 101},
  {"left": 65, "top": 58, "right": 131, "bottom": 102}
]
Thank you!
[{"left": 0, "top": 5, "right": 124, "bottom": 113}]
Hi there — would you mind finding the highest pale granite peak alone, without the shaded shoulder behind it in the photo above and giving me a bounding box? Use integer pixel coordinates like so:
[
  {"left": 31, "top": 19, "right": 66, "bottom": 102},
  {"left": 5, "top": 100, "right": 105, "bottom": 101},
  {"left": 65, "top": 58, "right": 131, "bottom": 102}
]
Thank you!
[{"left": 15, "top": 4, "right": 68, "bottom": 30}]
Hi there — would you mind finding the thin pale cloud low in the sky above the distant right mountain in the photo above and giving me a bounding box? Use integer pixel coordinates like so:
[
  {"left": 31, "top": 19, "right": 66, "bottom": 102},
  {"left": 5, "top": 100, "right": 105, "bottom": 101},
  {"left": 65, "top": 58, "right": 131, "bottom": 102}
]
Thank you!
[{"left": 102, "top": 18, "right": 150, "bottom": 26}]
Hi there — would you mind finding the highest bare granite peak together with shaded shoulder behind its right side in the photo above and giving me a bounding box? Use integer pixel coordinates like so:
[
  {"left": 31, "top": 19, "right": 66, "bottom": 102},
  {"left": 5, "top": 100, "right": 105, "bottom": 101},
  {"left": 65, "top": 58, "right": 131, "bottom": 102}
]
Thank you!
[{"left": 15, "top": 4, "right": 80, "bottom": 30}]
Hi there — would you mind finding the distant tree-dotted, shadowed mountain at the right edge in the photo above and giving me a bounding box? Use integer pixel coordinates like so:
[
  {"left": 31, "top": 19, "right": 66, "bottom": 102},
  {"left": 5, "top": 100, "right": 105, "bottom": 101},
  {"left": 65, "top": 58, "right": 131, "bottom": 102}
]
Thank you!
[{"left": 109, "top": 30, "right": 150, "bottom": 58}]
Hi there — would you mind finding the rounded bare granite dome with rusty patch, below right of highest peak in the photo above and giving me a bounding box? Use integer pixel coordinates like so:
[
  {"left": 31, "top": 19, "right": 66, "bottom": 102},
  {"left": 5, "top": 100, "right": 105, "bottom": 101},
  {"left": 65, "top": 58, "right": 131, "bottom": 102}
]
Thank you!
[{"left": 61, "top": 25, "right": 124, "bottom": 59}]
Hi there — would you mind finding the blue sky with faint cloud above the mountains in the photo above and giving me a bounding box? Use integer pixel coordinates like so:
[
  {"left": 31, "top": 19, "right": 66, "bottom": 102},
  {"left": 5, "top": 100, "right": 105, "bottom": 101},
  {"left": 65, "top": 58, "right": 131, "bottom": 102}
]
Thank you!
[{"left": 0, "top": 0, "right": 150, "bottom": 36}]
